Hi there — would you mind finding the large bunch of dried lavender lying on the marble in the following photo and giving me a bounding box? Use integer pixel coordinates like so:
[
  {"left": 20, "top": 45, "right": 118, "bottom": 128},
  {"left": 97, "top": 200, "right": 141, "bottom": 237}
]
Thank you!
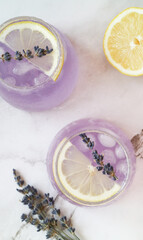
[{"left": 13, "top": 169, "right": 80, "bottom": 240}]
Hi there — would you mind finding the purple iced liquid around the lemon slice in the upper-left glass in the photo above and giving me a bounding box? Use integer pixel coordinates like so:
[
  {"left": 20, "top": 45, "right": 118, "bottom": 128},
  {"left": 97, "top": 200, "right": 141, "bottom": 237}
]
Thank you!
[{"left": 0, "top": 18, "right": 78, "bottom": 111}]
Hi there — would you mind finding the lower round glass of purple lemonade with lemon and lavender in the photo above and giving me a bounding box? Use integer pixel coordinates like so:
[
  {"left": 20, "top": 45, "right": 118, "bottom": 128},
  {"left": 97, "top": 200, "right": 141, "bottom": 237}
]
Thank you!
[{"left": 47, "top": 119, "right": 136, "bottom": 206}]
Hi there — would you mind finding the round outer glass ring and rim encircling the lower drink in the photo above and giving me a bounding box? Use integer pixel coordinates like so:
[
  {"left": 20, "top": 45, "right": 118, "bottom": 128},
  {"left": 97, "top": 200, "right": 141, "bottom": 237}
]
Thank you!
[{"left": 47, "top": 119, "right": 135, "bottom": 206}]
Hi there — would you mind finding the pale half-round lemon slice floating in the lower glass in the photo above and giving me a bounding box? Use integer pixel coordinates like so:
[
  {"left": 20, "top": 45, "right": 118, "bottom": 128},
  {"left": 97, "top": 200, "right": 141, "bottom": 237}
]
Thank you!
[{"left": 53, "top": 139, "right": 121, "bottom": 204}]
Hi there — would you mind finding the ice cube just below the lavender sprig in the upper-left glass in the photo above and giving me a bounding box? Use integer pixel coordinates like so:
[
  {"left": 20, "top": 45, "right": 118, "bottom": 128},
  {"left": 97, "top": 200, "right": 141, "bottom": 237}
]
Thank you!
[{"left": 13, "top": 60, "right": 35, "bottom": 75}]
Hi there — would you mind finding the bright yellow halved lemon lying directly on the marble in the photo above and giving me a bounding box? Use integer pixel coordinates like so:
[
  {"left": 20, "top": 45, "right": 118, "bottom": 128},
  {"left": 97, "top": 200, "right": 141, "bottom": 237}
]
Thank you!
[{"left": 103, "top": 8, "right": 143, "bottom": 76}]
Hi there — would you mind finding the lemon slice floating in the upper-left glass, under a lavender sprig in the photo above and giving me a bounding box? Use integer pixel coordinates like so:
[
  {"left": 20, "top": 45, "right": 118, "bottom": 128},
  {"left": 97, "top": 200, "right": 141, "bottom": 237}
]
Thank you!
[{"left": 0, "top": 20, "right": 64, "bottom": 80}]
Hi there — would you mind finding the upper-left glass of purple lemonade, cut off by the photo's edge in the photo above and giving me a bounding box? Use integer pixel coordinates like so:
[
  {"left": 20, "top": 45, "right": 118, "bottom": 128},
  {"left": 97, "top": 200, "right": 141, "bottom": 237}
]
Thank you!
[{"left": 0, "top": 17, "right": 78, "bottom": 111}]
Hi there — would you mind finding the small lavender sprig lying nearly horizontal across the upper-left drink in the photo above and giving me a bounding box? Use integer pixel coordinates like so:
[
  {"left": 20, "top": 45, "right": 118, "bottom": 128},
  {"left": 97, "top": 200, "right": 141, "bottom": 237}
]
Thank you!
[{"left": 0, "top": 46, "right": 53, "bottom": 62}]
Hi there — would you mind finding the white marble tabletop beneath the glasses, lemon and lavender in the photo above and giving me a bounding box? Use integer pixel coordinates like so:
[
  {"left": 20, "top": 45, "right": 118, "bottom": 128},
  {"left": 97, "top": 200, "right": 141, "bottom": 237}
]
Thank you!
[{"left": 0, "top": 0, "right": 143, "bottom": 240}]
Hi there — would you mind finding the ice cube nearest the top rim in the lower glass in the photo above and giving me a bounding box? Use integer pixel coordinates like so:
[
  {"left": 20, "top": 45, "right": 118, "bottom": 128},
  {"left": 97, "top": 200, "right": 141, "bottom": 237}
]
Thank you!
[{"left": 98, "top": 133, "right": 116, "bottom": 147}]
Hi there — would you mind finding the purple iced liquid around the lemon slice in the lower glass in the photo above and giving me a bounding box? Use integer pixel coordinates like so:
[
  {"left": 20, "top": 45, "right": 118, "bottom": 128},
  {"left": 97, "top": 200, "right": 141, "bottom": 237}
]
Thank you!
[{"left": 47, "top": 119, "right": 135, "bottom": 206}]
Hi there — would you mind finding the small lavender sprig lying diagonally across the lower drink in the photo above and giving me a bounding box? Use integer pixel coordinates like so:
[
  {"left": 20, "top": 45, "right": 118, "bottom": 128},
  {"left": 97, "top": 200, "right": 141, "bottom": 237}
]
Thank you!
[{"left": 79, "top": 133, "right": 118, "bottom": 181}]
